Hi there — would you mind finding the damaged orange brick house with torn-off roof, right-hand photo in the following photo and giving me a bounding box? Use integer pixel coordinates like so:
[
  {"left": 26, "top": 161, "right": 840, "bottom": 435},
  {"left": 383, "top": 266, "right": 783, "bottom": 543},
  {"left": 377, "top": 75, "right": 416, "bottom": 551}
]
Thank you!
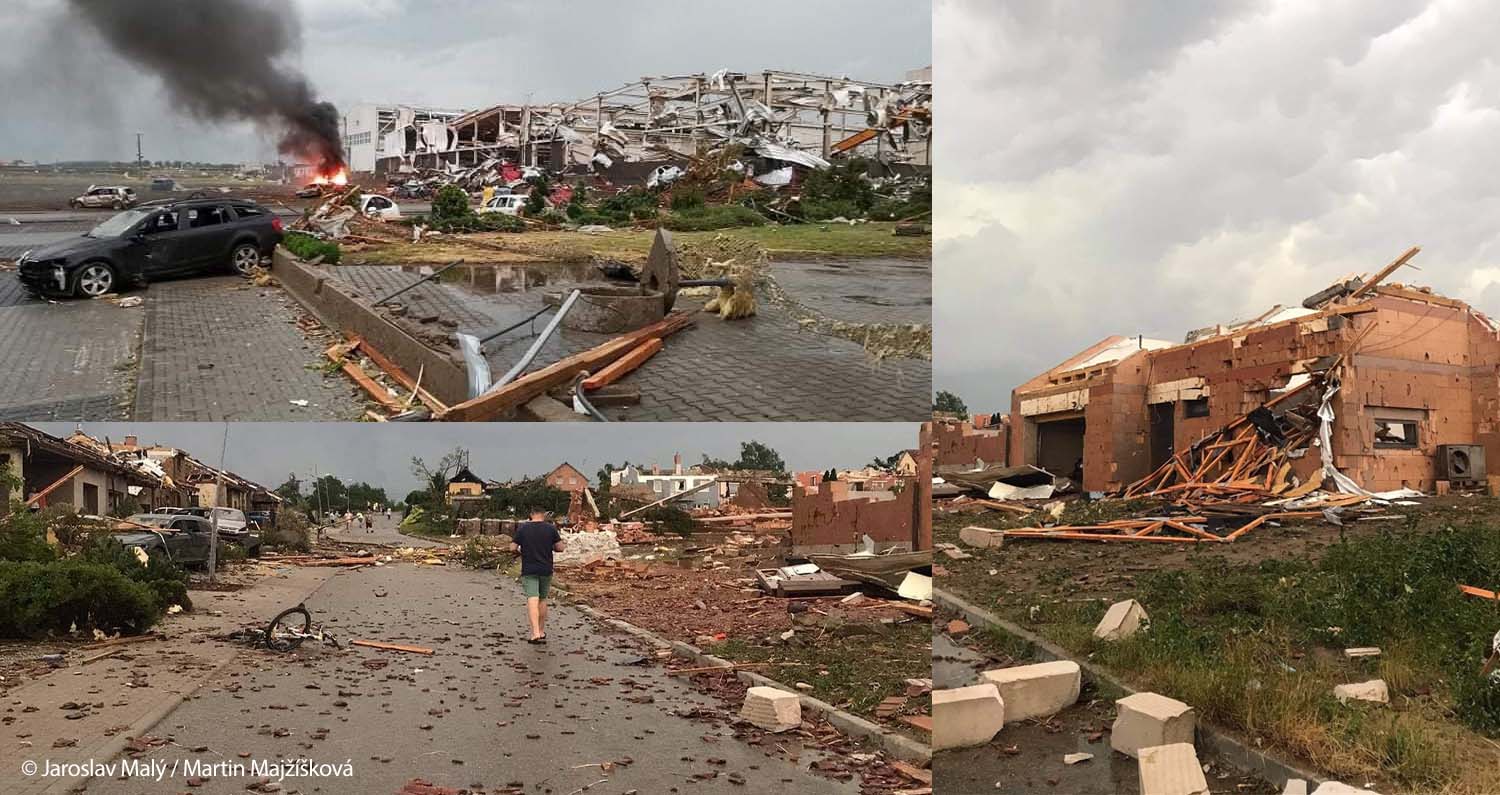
[{"left": 1010, "top": 248, "right": 1500, "bottom": 492}]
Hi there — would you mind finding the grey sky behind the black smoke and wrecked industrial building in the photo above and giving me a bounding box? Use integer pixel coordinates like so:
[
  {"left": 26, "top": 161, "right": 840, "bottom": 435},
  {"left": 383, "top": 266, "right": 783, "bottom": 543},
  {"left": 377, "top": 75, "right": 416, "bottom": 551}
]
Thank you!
[{"left": 0, "top": 0, "right": 932, "bottom": 162}]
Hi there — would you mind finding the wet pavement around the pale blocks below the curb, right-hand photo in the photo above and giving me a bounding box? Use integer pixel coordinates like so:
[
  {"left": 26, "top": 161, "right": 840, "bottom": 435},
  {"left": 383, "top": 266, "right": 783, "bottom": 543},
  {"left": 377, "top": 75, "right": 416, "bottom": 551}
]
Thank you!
[{"left": 933, "top": 633, "right": 1277, "bottom": 795}]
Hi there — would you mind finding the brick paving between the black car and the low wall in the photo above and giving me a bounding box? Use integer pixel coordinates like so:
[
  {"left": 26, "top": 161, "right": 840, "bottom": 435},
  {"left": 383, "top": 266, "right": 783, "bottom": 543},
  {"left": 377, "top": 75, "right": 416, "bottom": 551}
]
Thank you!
[{"left": 134, "top": 276, "right": 363, "bottom": 422}]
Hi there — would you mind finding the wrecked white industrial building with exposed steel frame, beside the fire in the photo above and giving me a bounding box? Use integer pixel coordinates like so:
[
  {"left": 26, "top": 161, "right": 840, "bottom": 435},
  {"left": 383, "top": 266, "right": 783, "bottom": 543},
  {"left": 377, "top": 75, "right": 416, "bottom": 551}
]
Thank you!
[{"left": 345, "top": 66, "right": 932, "bottom": 185}]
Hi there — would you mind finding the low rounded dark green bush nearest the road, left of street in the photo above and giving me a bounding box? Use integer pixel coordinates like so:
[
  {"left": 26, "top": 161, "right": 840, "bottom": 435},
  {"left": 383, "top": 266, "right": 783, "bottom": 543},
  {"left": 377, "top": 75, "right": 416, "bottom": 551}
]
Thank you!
[{"left": 0, "top": 560, "right": 165, "bottom": 638}]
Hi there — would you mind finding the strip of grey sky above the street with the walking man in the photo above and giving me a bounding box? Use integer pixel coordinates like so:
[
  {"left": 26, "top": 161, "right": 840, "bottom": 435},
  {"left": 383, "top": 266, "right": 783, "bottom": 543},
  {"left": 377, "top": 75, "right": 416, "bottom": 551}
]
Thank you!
[{"left": 29, "top": 423, "right": 918, "bottom": 500}]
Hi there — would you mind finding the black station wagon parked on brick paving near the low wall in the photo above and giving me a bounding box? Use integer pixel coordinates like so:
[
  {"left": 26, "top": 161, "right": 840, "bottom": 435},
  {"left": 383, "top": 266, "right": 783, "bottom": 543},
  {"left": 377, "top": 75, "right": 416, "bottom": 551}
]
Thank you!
[{"left": 17, "top": 198, "right": 282, "bottom": 299}]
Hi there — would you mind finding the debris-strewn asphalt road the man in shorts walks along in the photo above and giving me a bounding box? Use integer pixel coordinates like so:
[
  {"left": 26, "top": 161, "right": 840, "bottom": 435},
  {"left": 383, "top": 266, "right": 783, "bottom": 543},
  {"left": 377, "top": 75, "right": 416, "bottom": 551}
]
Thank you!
[{"left": 87, "top": 564, "right": 857, "bottom": 795}]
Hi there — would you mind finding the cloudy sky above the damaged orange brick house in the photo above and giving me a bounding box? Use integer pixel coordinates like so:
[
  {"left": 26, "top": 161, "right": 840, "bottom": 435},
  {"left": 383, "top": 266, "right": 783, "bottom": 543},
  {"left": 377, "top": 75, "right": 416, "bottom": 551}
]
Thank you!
[{"left": 933, "top": 0, "right": 1500, "bottom": 410}]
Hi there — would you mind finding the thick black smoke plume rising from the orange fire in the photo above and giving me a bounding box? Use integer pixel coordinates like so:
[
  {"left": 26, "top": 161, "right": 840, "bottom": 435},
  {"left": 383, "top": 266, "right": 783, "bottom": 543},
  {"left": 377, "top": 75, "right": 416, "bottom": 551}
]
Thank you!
[{"left": 69, "top": 0, "right": 344, "bottom": 174}]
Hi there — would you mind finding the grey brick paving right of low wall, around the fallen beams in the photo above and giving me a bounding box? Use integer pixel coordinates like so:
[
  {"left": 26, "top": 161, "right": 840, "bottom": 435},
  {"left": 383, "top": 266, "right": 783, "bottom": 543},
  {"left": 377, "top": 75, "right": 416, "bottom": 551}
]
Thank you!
[{"left": 333, "top": 263, "right": 932, "bottom": 422}]
